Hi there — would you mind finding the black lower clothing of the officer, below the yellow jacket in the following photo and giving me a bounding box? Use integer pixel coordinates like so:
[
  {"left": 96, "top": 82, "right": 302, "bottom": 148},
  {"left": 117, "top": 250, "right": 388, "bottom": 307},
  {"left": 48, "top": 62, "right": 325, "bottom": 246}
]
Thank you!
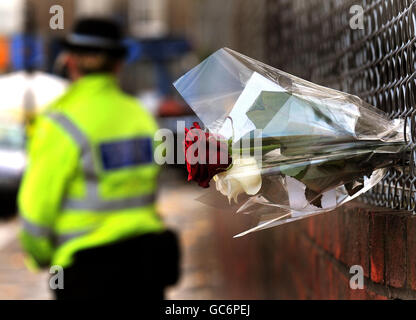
[{"left": 53, "top": 231, "right": 179, "bottom": 300}]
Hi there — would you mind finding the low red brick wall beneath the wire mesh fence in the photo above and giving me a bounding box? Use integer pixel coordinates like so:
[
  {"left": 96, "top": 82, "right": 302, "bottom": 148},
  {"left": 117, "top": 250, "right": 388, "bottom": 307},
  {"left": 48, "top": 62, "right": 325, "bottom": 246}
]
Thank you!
[{"left": 215, "top": 202, "right": 416, "bottom": 299}]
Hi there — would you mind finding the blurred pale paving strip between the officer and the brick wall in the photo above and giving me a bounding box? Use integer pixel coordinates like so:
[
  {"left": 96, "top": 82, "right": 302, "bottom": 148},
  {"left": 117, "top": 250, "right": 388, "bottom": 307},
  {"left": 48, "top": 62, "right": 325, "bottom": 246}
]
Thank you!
[{"left": 159, "top": 171, "right": 222, "bottom": 299}]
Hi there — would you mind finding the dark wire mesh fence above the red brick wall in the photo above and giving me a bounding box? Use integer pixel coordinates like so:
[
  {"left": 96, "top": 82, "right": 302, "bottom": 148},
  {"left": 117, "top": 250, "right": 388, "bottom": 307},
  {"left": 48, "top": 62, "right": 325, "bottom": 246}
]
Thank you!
[{"left": 266, "top": 0, "right": 416, "bottom": 211}]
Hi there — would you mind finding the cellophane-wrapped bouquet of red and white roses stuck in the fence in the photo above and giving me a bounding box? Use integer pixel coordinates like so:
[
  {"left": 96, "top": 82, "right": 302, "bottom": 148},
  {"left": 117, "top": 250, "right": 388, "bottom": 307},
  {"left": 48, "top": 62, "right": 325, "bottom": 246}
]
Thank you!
[{"left": 174, "top": 48, "right": 408, "bottom": 236}]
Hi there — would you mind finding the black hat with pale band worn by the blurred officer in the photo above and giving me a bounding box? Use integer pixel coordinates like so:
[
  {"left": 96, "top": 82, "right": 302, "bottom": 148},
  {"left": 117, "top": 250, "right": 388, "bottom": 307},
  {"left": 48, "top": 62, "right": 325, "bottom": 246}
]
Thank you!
[{"left": 64, "top": 18, "right": 127, "bottom": 58}]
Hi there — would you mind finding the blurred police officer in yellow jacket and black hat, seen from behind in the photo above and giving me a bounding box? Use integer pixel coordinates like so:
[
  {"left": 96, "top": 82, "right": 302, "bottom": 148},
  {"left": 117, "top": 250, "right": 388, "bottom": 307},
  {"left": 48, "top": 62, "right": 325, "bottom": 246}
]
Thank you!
[{"left": 18, "top": 18, "right": 179, "bottom": 299}]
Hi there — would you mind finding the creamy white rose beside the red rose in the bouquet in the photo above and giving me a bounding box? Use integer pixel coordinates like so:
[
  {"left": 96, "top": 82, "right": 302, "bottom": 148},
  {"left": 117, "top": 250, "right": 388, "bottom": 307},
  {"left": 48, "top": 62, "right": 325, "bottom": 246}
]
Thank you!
[{"left": 214, "top": 157, "right": 261, "bottom": 203}]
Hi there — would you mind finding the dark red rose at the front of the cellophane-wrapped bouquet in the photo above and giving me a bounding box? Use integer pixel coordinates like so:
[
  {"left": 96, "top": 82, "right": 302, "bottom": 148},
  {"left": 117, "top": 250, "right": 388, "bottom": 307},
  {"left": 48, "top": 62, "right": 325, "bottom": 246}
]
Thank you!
[{"left": 184, "top": 122, "right": 231, "bottom": 188}]
